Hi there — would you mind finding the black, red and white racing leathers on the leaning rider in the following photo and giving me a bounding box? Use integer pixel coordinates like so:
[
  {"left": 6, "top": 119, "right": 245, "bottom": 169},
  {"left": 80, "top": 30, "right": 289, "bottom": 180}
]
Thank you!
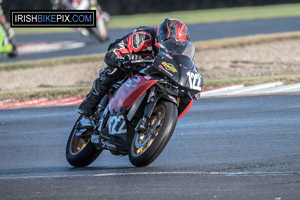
[{"left": 78, "top": 27, "right": 156, "bottom": 116}]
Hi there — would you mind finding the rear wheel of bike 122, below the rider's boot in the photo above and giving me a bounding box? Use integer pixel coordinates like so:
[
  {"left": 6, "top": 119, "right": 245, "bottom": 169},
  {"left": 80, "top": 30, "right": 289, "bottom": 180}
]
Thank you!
[{"left": 66, "top": 115, "right": 102, "bottom": 167}]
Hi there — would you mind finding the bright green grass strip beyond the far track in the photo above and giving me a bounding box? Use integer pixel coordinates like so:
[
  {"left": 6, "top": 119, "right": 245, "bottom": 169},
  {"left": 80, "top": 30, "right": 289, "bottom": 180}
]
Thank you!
[{"left": 15, "top": 3, "right": 300, "bottom": 34}]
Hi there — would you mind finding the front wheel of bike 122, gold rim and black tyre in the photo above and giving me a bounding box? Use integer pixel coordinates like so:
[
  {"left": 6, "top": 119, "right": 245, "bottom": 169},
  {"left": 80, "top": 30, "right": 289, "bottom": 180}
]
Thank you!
[{"left": 129, "top": 100, "right": 178, "bottom": 167}]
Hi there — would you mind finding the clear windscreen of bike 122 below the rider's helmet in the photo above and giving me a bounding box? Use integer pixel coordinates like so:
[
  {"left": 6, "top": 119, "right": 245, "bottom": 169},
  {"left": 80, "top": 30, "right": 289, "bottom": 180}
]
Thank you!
[{"left": 160, "top": 39, "right": 195, "bottom": 60}]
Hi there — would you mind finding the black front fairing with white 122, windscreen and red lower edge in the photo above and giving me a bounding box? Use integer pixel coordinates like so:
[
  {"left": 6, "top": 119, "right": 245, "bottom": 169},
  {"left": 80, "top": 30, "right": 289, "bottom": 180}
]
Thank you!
[{"left": 145, "top": 39, "right": 203, "bottom": 120}]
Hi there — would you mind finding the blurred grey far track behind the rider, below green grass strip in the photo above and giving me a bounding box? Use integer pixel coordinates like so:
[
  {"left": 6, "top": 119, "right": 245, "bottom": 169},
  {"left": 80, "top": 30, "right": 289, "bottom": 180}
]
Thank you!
[{"left": 0, "top": 17, "right": 300, "bottom": 62}]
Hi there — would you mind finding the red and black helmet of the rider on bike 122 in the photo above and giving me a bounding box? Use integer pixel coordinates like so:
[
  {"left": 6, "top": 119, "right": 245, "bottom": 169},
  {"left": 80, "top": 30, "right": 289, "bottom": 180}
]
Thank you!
[{"left": 157, "top": 18, "right": 190, "bottom": 43}]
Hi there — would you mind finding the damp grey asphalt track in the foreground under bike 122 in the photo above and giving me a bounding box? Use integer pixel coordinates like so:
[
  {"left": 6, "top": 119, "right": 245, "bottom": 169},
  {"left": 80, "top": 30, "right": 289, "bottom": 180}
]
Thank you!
[{"left": 0, "top": 95, "right": 300, "bottom": 200}]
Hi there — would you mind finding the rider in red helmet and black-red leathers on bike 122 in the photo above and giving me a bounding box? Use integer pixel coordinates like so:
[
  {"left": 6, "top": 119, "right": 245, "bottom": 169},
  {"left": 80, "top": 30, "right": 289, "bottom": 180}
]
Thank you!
[{"left": 78, "top": 18, "right": 190, "bottom": 117}]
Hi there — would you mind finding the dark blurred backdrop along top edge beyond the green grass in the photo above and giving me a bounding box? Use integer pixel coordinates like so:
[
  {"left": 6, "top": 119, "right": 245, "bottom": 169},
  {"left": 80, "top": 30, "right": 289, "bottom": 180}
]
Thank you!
[{"left": 3, "top": 0, "right": 300, "bottom": 17}]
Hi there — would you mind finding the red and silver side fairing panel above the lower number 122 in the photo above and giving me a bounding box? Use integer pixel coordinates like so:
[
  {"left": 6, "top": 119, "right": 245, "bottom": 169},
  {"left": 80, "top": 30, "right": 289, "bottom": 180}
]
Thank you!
[{"left": 109, "top": 74, "right": 157, "bottom": 112}]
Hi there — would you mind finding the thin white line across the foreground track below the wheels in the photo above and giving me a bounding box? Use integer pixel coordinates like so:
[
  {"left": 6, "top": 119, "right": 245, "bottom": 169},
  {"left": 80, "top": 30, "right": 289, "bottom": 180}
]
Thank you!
[{"left": 0, "top": 171, "right": 300, "bottom": 180}]
